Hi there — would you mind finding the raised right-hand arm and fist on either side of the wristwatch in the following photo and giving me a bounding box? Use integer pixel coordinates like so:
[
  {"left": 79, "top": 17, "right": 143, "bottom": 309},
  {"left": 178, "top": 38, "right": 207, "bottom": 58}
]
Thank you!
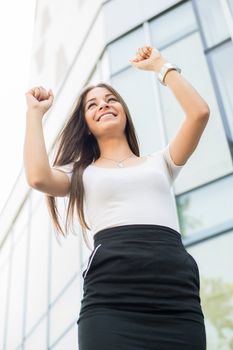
[{"left": 131, "top": 47, "right": 210, "bottom": 165}]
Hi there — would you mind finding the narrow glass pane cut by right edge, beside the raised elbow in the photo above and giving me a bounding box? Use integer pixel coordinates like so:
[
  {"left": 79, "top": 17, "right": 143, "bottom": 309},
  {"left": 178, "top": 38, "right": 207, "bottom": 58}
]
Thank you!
[{"left": 210, "top": 42, "right": 233, "bottom": 137}]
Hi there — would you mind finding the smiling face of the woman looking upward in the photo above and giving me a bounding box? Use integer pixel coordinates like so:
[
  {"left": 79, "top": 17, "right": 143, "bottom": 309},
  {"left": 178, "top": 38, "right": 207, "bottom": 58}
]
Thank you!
[{"left": 84, "top": 87, "right": 126, "bottom": 138}]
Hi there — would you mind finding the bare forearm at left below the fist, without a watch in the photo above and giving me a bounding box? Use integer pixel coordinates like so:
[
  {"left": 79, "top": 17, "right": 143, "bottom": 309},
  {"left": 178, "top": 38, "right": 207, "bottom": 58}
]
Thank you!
[{"left": 24, "top": 109, "right": 50, "bottom": 186}]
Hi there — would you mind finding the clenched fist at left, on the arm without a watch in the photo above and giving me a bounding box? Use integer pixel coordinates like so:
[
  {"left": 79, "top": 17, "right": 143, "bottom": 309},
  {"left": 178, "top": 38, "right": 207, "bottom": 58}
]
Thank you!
[{"left": 25, "top": 86, "right": 54, "bottom": 114}]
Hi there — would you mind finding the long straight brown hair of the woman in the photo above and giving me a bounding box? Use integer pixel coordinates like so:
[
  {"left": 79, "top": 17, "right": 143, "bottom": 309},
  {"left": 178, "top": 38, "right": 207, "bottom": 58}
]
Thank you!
[{"left": 46, "top": 83, "right": 140, "bottom": 250}]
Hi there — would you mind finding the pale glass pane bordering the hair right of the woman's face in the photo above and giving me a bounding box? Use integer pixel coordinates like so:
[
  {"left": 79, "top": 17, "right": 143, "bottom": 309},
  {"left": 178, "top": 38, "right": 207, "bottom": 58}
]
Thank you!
[{"left": 111, "top": 68, "right": 163, "bottom": 155}]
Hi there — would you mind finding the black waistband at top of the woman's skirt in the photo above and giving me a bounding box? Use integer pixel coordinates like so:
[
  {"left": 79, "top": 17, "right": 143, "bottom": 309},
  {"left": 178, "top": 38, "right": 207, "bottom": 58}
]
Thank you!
[{"left": 93, "top": 224, "right": 182, "bottom": 247}]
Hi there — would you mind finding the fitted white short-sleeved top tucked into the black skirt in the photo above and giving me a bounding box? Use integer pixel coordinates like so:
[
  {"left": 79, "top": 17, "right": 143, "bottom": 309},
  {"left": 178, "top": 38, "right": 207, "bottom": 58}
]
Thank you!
[{"left": 54, "top": 144, "right": 184, "bottom": 234}]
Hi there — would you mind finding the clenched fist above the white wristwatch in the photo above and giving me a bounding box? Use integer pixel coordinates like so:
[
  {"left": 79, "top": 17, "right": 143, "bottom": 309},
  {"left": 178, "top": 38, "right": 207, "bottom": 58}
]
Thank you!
[{"left": 129, "top": 46, "right": 168, "bottom": 73}]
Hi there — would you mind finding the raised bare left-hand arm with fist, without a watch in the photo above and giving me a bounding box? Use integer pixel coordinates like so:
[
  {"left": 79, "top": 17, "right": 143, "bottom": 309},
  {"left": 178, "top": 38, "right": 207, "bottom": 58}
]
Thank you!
[{"left": 24, "top": 87, "right": 70, "bottom": 197}]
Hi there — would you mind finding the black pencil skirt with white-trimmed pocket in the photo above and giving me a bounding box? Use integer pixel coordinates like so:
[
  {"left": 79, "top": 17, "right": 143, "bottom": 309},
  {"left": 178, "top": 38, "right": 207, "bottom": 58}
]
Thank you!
[{"left": 77, "top": 224, "right": 206, "bottom": 350}]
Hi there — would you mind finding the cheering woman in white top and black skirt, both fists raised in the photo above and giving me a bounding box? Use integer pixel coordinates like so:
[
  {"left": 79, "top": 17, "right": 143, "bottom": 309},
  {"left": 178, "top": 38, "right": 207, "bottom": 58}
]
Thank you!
[{"left": 24, "top": 46, "right": 209, "bottom": 350}]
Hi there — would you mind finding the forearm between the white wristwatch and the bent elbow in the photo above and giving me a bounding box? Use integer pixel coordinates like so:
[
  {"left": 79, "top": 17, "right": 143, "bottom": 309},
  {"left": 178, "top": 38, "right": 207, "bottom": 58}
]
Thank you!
[{"left": 160, "top": 70, "right": 209, "bottom": 118}]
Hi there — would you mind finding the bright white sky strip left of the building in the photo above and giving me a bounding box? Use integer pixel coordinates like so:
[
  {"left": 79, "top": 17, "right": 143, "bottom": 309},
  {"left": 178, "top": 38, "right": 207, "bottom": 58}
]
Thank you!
[{"left": 0, "top": 0, "right": 36, "bottom": 213}]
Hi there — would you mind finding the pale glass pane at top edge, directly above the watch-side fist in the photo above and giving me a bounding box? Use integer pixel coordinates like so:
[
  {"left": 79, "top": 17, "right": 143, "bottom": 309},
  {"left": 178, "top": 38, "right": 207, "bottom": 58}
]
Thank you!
[{"left": 150, "top": 2, "right": 197, "bottom": 48}]
